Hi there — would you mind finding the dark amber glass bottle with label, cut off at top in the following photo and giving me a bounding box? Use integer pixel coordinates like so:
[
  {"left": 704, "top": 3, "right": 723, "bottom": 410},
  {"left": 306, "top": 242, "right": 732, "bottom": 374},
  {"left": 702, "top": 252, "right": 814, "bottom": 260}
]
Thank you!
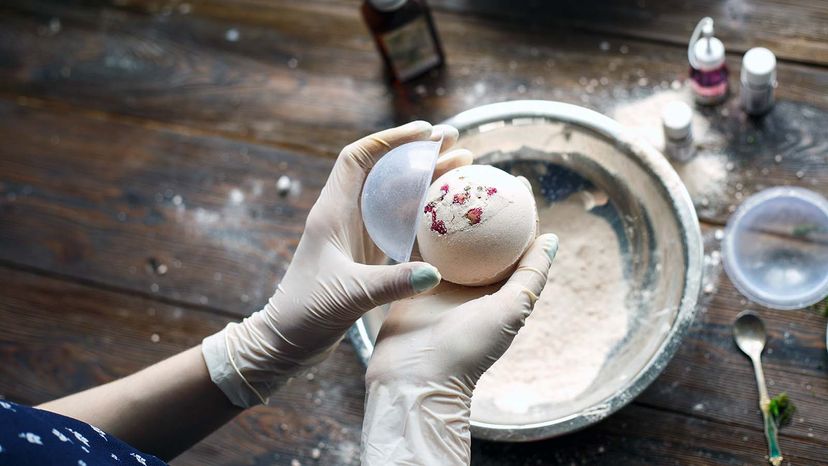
[{"left": 362, "top": 0, "right": 445, "bottom": 82}]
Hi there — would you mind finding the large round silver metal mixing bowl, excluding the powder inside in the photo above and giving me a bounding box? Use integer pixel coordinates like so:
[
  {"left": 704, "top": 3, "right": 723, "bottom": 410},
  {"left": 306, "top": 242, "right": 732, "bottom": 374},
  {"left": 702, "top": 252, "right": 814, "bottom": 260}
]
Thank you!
[{"left": 349, "top": 101, "right": 703, "bottom": 441}]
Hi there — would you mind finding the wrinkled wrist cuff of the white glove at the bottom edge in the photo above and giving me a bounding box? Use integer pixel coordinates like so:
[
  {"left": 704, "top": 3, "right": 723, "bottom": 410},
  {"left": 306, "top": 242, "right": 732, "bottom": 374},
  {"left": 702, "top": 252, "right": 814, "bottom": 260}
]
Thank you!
[{"left": 362, "top": 382, "right": 471, "bottom": 466}]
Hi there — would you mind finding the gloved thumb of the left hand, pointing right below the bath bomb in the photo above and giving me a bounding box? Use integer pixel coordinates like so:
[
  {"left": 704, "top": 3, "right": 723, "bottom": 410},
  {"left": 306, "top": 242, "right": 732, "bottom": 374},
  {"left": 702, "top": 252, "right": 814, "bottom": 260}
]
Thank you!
[{"left": 354, "top": 262, "right": 441, "bottom": 309}]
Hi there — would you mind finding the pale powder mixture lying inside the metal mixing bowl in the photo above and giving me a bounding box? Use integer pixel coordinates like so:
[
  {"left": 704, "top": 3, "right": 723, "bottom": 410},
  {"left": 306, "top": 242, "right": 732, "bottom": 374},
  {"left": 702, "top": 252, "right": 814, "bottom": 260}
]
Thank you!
[{"left": 472, "top": 195, "right": 628, "bottom": 417}]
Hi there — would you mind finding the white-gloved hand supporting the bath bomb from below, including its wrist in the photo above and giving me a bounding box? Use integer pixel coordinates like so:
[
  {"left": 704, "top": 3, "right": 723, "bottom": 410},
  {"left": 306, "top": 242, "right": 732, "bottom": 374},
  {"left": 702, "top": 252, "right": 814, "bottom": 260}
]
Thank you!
[{"left": 362, "top": 234, "right": 558, "bottom": 466}]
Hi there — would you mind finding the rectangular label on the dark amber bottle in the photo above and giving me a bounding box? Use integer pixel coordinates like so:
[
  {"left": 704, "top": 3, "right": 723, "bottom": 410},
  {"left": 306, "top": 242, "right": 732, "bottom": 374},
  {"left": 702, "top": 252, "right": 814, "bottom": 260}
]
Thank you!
[{"left": 380, "top": 17, "right": 440, "bottom": 81}]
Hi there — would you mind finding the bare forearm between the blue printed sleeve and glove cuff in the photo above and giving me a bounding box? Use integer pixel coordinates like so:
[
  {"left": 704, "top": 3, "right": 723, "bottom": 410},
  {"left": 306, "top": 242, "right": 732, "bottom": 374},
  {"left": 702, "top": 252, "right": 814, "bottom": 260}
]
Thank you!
[{"left": 38, "top": 346, "right": 242, "bottom": 460}]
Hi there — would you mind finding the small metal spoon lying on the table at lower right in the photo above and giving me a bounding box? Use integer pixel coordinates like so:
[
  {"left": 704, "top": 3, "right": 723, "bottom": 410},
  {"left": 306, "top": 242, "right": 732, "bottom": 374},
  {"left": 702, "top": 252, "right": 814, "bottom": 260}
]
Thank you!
[{"left": 733, "top": 311, "right": 782, "bottom": 466}]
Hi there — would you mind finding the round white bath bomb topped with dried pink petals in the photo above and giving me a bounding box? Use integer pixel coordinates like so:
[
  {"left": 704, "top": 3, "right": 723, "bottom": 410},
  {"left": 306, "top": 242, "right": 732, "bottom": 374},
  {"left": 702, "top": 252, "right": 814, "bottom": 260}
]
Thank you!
[{"left": 417, "top": 165, "right": 538, "bottom": 286}]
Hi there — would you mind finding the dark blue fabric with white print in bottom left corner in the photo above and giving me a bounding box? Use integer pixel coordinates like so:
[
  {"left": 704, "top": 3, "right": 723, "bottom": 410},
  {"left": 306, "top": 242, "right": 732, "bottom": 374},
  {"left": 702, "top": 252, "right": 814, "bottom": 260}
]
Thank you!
[{"left": 0, "top": 400, "right": 166, "bottom": 466}]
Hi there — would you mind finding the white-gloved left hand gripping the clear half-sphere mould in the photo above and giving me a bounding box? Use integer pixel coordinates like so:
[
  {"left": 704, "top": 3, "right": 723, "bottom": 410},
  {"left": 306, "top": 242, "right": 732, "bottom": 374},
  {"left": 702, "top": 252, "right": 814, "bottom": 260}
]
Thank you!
[{"left": 202, "top": 121, "right": 472, "bottom": 407}]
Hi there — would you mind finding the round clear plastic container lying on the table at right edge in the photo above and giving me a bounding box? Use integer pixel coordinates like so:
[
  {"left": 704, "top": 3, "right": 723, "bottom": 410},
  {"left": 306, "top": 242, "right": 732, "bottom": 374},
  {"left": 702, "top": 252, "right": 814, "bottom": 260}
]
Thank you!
[{"left": 722, "top": 186, "right": 828, "bottom": 309}]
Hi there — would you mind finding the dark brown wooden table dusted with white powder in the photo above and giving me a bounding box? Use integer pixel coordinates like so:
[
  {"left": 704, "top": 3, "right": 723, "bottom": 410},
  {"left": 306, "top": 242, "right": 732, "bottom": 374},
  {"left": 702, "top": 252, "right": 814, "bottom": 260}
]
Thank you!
[{"left": 0, "top": 0, "right": 828, "bottom": 466}]
